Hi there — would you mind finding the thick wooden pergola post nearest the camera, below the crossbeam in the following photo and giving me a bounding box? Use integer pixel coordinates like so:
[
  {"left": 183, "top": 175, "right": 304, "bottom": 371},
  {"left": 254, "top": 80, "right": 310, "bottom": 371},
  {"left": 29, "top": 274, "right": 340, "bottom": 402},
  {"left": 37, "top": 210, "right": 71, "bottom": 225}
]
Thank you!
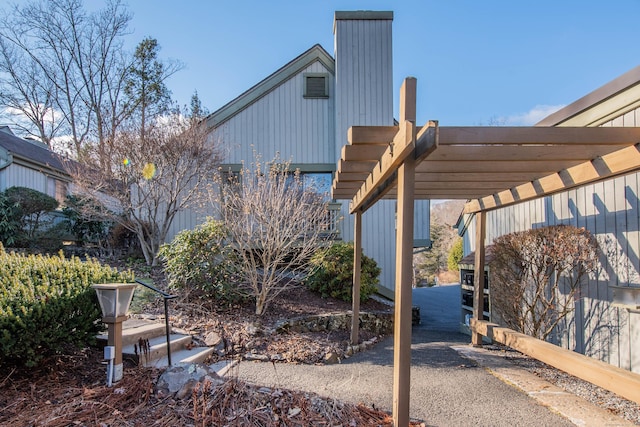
[{"left": 393, "top": 157, "right": 415, "bottom": 426}]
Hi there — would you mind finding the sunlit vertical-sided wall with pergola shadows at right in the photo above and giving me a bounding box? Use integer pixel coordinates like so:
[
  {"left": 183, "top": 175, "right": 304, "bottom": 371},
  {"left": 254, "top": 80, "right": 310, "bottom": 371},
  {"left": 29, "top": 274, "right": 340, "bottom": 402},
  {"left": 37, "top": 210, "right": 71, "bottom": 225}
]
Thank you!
[{"left": 464, "top": 109, "right": 640, "bottom": 372}]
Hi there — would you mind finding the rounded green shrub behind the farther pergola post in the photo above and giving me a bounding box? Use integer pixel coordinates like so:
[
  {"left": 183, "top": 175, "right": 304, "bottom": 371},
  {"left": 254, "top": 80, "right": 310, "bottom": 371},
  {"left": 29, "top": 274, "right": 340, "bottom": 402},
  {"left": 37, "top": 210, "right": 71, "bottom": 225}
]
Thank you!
[{"left": 305, "top": 243, "right": 380, "bottom": 302}]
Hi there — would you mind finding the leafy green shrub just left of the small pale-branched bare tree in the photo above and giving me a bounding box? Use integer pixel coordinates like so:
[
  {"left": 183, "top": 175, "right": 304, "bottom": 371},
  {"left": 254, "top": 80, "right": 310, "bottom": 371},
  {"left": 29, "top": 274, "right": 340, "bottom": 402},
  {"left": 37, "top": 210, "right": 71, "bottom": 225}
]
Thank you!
[{"left": 159, "top": 218, "right": 243, "bottom": 302}]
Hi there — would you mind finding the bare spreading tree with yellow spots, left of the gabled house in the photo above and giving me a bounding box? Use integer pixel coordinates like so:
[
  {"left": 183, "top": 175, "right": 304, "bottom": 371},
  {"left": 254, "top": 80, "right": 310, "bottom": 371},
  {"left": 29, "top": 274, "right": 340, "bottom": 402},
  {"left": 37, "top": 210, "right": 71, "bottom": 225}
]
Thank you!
[{"left": 68, "top": 105, "right": 221, "bottom": 265}]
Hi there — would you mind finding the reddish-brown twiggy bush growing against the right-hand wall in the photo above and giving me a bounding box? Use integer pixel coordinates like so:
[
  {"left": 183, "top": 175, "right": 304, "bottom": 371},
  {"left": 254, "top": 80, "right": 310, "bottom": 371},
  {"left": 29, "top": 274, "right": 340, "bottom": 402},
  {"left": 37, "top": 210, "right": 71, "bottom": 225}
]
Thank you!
[{"left": 490, "top": 225, "right": 598, "bottom": 340}]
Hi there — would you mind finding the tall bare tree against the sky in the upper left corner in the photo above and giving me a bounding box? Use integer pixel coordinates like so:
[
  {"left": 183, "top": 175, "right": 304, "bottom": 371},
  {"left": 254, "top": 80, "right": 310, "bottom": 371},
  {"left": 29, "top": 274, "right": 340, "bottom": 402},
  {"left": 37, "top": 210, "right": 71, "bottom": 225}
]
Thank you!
[{"left": 0, "top": 0, "right": 131, "bottom": 156}]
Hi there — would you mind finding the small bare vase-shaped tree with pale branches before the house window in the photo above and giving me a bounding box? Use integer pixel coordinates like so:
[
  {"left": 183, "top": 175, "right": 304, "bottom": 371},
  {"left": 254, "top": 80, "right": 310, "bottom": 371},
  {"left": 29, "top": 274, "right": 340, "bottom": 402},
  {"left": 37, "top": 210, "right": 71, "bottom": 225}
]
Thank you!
[{"left": 219, "top": 155, "right": 330, "bottom": 315}]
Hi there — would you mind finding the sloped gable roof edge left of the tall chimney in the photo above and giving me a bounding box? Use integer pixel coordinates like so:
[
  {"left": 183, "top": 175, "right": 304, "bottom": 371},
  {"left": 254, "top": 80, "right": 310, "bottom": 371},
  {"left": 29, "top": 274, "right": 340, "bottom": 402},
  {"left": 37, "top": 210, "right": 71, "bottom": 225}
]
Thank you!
[{"left": 206, "top": 44, "right": 335, "bottom": 128}]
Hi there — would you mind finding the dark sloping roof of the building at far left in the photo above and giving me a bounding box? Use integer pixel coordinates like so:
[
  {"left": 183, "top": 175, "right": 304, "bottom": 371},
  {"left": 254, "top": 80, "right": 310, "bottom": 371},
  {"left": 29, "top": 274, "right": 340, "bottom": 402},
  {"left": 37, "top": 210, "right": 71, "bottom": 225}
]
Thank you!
[{"left": 0, "top": 126, "right": 66, "bottom": 175}]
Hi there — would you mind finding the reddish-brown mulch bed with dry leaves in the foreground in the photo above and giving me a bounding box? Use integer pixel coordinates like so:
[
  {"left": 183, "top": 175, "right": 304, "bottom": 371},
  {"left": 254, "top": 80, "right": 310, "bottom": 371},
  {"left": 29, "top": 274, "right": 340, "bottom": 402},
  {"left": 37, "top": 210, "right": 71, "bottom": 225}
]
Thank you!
[{"left": 0, "top": 350, "right": 421, "bottom": 427}]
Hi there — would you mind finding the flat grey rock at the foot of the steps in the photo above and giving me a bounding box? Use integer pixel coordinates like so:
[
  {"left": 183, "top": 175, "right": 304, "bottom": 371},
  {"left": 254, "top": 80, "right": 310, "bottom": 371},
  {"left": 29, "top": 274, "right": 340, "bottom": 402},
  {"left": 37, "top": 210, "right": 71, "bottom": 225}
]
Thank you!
[{"left": 156, "top": 363, "right": 224, "bottom": 398}]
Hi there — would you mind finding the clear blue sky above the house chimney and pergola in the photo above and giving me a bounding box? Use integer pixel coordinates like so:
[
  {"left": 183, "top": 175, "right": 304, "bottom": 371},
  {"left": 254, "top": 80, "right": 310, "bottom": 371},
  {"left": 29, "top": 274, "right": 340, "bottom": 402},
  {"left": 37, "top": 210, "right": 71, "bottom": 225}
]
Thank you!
[{"left": 121, "top": 0, "right": 640, "bottom": 125}]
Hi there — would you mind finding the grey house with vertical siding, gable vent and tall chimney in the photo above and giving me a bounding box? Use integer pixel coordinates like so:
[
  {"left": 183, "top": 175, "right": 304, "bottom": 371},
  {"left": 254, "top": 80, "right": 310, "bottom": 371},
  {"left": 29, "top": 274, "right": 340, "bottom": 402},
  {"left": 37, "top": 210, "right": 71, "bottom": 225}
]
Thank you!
[{"left": 169, "top": 11, "right": 429, "bottom": 297}]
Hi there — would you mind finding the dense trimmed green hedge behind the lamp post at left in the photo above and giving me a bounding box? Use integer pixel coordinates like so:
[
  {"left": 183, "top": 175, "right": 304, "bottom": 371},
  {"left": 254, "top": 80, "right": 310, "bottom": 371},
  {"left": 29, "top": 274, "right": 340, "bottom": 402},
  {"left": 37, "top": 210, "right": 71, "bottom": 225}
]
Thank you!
[{"left": 0, "top": 245, "right": 133, "bottom": 367}]
